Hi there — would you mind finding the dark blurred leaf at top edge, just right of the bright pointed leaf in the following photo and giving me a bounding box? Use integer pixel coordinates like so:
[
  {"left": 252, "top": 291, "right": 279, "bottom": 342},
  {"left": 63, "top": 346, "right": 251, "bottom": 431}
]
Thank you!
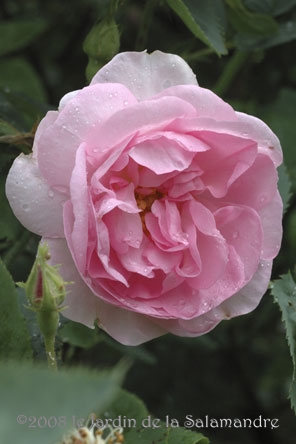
[{"left": 226, "top": 0, "right": 278, "bottom": 36}]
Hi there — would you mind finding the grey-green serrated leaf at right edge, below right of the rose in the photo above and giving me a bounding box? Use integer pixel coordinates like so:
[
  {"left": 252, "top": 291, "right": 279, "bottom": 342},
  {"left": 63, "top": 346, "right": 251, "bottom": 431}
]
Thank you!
[{"left": 271, "top": 273, "right": 296, "bottom": 413}]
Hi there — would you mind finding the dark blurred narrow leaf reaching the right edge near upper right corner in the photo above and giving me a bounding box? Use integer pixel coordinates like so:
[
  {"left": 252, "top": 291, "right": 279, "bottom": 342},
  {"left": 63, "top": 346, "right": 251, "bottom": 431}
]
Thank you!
[{"left": 234, "top": 20, "right": 296, "bottom": 51}]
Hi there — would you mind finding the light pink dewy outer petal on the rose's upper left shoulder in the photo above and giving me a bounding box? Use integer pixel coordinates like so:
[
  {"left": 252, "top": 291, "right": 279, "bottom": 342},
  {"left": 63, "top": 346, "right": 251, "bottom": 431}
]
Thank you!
[{"left": 38, "top": 84, "right": 136, "bottom": 187}]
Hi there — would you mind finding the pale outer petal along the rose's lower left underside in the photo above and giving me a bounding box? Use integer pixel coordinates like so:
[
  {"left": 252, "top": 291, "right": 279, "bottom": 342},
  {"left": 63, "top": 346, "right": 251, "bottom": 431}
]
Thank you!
[{"left": 43, "top": 239, "right": 166, "bottom": 345}]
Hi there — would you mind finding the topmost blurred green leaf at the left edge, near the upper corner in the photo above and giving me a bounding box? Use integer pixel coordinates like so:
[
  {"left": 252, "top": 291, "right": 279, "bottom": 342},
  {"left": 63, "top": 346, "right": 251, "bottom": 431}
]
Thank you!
[{"left": 0, "top": 18, "right": 47, "bottom": 56}]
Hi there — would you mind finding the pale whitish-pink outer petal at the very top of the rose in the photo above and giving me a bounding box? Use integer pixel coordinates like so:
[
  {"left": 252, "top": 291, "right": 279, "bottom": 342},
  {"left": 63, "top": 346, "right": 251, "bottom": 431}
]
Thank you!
[{"left": 91, "top": 51, "right": 197, "bottom": 100}]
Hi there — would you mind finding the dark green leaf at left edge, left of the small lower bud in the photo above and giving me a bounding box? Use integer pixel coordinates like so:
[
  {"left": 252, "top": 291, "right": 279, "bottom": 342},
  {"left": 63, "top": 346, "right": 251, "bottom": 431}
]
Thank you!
[{"left": 0, "top": 260, "right": 32, "bottom": 360}]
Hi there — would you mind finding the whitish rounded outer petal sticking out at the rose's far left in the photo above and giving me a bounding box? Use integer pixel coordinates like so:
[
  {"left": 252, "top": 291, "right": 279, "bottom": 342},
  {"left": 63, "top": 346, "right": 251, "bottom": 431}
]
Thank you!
[{"left": 6, "top": 154, "right": 69, "bottom": 237}]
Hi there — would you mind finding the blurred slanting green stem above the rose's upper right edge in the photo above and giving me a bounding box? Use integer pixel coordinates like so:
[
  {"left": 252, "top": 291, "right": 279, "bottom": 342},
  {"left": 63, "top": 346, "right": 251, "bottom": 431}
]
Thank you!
[{"left": 214, "top": 51, "right": 249, "bottom": 97}]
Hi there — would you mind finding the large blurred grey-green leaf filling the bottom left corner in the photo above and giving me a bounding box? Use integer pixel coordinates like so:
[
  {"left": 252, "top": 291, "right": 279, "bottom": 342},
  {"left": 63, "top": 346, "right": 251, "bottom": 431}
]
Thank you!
[{"left": 0, "top": 362, "right": 123, "bottom": 444}]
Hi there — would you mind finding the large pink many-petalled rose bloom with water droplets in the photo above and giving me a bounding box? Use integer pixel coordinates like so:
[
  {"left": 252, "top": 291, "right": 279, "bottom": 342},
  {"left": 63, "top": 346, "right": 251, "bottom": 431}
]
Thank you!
[{"left": 6, "top": 51, "right": 282, "bottom": 345}]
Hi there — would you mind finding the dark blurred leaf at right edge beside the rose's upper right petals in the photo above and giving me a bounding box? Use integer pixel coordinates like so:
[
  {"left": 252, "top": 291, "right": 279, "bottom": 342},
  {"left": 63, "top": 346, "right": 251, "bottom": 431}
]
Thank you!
[{"left": 263, "top": 88, "right": 296, "bottom": 191}]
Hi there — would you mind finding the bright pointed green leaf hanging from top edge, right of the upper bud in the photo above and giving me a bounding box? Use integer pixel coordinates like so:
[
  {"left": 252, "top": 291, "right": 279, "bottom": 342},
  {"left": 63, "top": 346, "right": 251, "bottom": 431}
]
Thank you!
[{"left": 167, "top": 0, "right": 227, "bottom": 55}]
